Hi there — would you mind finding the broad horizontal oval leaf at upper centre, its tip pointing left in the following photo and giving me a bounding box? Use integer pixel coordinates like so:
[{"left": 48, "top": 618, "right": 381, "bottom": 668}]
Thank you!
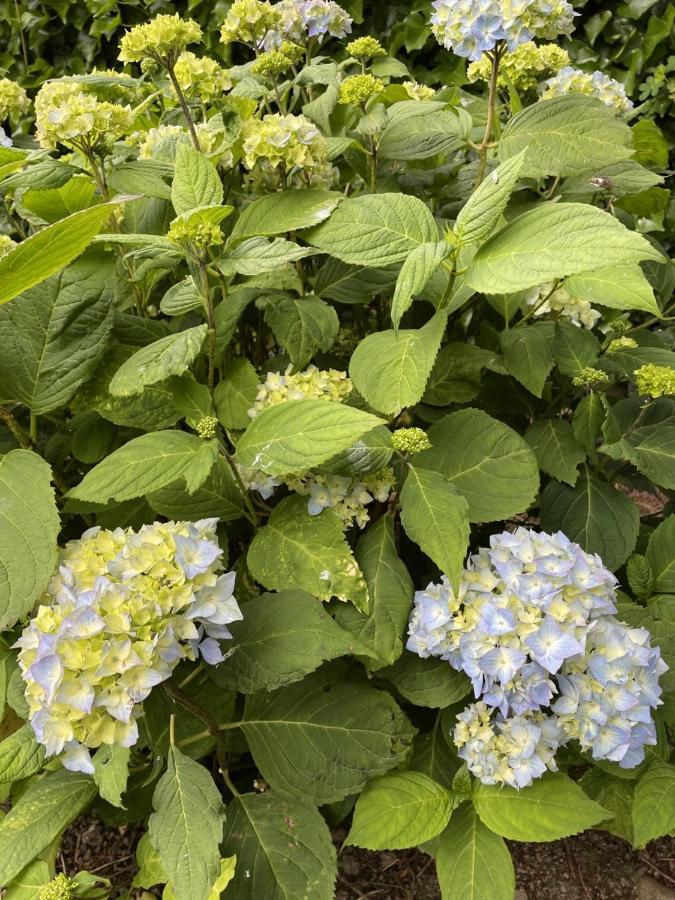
[{"left": 304, "top": 194, "right": 438, "bottom": 267}]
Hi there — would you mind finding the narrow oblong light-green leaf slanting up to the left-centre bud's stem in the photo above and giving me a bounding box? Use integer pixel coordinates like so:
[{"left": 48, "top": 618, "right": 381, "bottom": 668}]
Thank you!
[{"left": 108, "top": 325, "right": 208, "bottom": 397}]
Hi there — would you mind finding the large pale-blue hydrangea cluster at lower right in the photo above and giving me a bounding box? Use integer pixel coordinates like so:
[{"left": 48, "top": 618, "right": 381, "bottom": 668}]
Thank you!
[{"left": 407, "top": 528, "right": 666, "bottom": 787}]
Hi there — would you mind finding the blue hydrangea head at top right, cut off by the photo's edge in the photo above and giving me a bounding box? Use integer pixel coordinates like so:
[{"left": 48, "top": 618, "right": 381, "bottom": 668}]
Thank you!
[{"left": 430, "top": 0, "right": 577, "bottom": 60}]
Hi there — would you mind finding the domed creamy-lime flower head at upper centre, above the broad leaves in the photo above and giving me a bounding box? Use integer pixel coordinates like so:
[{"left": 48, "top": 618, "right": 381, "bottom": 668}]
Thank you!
[{"left": 242, "top": 113, "right": 328, "bottom": 169}]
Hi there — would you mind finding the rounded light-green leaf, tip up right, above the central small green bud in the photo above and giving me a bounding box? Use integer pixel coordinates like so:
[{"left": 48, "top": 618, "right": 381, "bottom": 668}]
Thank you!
[{"left": 349, "top": 312, "right": 448, "bottom": 415}]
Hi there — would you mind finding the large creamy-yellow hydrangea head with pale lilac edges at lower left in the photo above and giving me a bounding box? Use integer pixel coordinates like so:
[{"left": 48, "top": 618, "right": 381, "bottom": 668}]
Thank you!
[{"left": 15, "top": 519, "right": 242, "bottom": 773}]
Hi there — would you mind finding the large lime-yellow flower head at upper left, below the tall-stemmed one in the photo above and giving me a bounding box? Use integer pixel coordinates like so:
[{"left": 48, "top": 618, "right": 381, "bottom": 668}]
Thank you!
[{"left": 35, "top": 80, "right": 133, "bottom": 152}]
